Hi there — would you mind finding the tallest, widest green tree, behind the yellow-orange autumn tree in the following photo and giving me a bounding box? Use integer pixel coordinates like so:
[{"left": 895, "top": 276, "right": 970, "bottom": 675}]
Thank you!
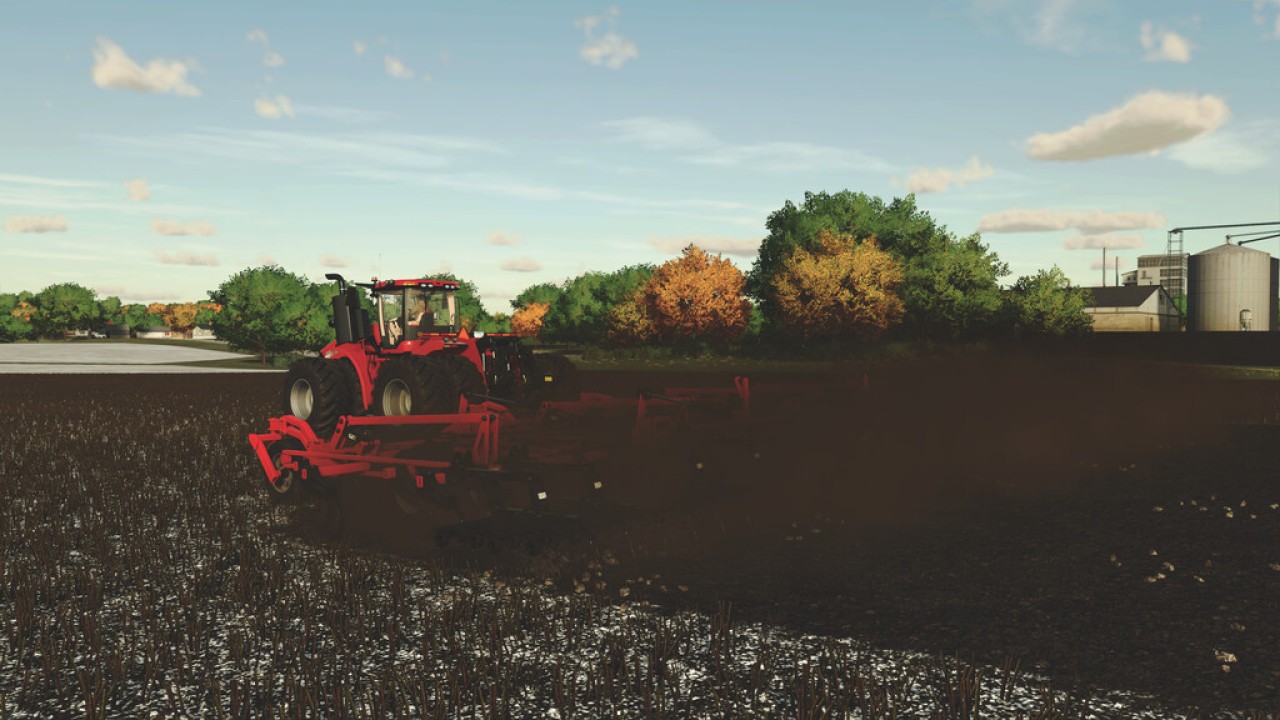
[{"left": 746, "top": 190, "right": 1009, "bottom": 337}]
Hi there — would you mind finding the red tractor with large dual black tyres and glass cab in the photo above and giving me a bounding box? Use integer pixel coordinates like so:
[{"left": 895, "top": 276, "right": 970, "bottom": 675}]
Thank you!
[{"left": 283, "top": 274, "right": 577, "bottom": 437}]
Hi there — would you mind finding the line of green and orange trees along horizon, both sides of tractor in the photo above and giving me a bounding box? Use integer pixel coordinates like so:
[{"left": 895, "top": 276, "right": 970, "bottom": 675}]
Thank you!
[{"left": 0, "top": 190, "right": 1091, "bottom": 359}]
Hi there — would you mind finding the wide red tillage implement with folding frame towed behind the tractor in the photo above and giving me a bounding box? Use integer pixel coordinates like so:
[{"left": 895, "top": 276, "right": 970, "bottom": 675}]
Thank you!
[{"left": 248, "top": 377, "right": 754, "bottom": 528}]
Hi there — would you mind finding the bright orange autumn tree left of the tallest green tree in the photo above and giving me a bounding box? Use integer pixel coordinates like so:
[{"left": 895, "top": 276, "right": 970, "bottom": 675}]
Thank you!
[{"left": 632, "top": 245, "right": 751, "bottom": 342}]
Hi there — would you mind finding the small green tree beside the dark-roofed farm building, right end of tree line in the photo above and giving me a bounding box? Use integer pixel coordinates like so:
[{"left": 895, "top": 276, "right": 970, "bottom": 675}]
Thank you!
[{"left": 1005, "top": 265, "right": 1093, "bottom": 337}]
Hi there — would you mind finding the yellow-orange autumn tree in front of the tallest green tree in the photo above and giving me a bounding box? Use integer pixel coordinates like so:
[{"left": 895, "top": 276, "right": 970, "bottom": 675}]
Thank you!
[{"left": 773, "top": 229, "right": 904, "bottom": 340}]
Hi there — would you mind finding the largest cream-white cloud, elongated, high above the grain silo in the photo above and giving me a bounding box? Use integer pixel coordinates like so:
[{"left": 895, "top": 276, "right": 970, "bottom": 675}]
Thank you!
[{"left": 1027, "top": 90, "right": 1230, "bottom": 160}]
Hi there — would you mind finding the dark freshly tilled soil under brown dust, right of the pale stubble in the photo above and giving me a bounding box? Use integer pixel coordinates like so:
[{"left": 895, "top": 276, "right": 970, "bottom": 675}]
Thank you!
[{"left": 290, "top": 357, "right": 1280, "bottom": 712}]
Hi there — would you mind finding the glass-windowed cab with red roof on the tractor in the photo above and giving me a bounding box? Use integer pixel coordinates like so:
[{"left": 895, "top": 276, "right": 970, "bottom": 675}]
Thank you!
[{"left": 370, "top": 279, "right": 458, "bottom": 347}]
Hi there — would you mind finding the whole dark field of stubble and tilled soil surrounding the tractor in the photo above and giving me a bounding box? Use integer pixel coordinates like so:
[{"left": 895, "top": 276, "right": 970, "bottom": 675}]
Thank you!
[{"left": 0, "top": 359, "right": 1280, "bottom": 717}]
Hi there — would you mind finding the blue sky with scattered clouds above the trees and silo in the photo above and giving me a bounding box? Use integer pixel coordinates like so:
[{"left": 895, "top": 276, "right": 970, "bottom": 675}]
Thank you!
[{"left": 0, "top": 0, "right": 1280, "bottom": 311}]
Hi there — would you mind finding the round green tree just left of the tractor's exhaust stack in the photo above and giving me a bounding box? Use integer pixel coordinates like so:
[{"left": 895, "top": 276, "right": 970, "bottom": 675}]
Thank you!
[{"left": 209, "top": 265, "right": 337, "bottom": 365}]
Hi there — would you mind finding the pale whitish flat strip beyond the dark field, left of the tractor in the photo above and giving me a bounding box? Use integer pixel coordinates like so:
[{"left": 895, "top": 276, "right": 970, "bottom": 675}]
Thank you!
[{"left": 0, "top": 341, "right": 276, "bottom": 374}]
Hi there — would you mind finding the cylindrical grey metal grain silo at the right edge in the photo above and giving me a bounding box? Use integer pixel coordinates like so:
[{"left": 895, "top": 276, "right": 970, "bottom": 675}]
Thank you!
[{"left": 1187, "top": 243, "right": 1277, "bottom": 332}]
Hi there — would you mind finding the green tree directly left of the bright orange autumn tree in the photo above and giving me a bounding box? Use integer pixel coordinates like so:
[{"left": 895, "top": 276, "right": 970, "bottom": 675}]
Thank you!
[{"left": 540, "top": 265, "right": 654, "bottom": 343}]
